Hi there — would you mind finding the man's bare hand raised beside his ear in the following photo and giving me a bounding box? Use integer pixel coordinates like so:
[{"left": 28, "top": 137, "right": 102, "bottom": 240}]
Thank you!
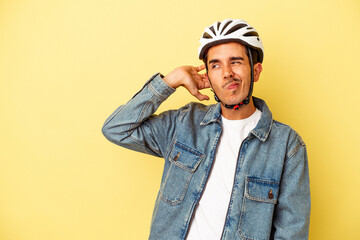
[{"left": 164, "top": 65, "right": 210, "bottom": 101}]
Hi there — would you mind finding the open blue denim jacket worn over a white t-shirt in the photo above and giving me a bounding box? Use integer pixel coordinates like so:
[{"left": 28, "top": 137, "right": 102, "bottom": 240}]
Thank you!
[{"left": 103, "top": 74, "right": 310, "bottom": 240}]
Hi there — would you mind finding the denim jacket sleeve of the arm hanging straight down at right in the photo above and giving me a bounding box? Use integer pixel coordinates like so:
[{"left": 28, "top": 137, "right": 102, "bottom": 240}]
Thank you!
[{"left": 271, "top": 137, "right": 311, "bottom": 240}]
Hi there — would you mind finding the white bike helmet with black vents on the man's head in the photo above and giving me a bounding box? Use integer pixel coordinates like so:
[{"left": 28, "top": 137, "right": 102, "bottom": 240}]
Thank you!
[{"left": 198, "top": 19, "right": 264, "bottom": 63}]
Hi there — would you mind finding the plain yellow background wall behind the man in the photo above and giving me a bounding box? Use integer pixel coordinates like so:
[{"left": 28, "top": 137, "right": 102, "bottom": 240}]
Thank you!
[{"left": 0, "top": 0, "right": 360, "bottom": 240}]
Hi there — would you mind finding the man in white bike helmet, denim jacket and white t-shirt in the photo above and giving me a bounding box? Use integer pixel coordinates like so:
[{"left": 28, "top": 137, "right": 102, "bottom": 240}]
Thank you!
[{"left": 103, "top": 19, "right": 310, "bottom": 240}]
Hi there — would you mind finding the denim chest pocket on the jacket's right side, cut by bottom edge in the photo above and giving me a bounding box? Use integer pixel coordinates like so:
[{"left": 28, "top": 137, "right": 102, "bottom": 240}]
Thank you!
[{"left": 239, "top": 177, "right": 279, "bottom": 240}]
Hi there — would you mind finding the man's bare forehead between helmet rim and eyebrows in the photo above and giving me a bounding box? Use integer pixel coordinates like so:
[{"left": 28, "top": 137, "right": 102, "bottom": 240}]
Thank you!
[{"left": 207, "top": 42, "right": 246, "bottom": 60}]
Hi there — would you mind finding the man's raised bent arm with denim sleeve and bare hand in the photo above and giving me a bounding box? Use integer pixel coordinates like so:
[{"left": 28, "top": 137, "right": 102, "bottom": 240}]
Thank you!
[{"left": 102, "top": 66, "right": 209, "bottom": 157}]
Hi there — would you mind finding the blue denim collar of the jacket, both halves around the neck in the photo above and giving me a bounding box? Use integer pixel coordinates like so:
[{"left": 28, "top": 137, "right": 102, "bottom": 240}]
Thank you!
[{"left": 200, "top": 97, "right": 273, "bottom": 142}]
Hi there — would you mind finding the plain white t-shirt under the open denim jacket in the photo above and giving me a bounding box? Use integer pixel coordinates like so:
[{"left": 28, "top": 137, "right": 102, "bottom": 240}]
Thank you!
[{"left": 186, "top": 109, "right": 261, "bottom": 240}]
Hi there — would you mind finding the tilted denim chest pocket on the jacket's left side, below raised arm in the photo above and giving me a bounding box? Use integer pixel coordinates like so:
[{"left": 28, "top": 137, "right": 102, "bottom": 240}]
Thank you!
[{"left": 160, "top": 142, "right": 204, "bottom": 205}]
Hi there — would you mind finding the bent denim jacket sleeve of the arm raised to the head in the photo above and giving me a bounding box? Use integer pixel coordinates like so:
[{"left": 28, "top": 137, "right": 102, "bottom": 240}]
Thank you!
[{"left": 102, "top": 74, "right": 177, "bottom": 157}]
